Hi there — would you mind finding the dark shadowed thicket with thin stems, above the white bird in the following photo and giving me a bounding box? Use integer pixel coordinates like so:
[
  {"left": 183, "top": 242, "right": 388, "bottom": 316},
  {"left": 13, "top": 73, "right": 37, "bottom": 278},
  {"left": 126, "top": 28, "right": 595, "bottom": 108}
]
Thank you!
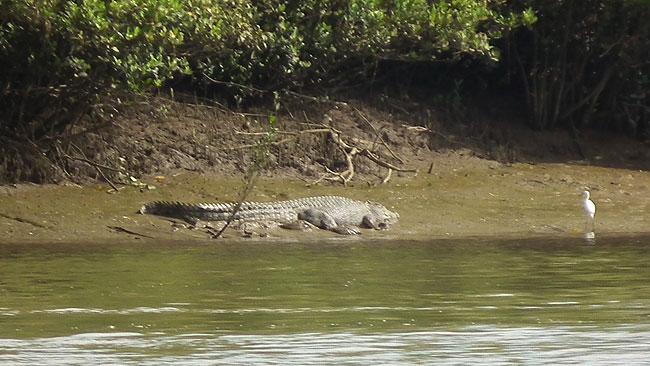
[{"left": 509, "top": 0, "right": 650, "bottom": 137}]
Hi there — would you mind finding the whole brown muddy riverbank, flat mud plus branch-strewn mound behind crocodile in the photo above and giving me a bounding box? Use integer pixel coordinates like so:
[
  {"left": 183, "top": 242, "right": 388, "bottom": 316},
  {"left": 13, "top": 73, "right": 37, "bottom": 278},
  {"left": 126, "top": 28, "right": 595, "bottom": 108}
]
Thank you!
[{"left": 0, "top": 95, "right": 650, "bottom": 243}]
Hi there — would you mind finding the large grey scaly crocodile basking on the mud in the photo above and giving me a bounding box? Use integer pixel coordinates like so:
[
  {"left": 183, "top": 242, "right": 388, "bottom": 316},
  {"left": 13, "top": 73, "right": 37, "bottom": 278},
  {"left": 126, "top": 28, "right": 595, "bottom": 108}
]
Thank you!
[{"left": 140, "top": 196, "right": 399, "bottom": 235}]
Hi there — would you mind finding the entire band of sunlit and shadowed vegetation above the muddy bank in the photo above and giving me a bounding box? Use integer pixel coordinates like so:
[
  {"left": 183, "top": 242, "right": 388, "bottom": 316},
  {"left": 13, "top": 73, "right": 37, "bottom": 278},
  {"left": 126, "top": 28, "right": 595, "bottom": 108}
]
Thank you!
[{"left": 0, "top": 0, "right": 650, "bottom": 180}]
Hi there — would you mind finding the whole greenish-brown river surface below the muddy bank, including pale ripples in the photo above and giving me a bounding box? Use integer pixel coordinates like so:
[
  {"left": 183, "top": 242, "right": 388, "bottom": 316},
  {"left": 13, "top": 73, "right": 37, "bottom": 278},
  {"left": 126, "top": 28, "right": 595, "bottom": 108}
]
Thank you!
[{"left": 0, "top": 237, "right": 650, "bottom": 365}]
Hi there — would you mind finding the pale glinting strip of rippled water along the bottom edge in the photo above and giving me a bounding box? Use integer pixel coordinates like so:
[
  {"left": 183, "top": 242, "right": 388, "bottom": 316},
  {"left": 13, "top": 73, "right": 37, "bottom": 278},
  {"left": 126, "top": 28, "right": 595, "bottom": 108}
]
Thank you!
[{"left": 0, "top": 326, "right": 650, "bottom": 365}]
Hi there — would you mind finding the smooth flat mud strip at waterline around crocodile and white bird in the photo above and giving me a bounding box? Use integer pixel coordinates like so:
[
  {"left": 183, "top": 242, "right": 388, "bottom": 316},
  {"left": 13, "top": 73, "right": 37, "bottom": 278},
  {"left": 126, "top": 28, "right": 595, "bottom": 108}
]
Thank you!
[{"left": 0, "top": 155, "right": 650, "bottom": 244}]
